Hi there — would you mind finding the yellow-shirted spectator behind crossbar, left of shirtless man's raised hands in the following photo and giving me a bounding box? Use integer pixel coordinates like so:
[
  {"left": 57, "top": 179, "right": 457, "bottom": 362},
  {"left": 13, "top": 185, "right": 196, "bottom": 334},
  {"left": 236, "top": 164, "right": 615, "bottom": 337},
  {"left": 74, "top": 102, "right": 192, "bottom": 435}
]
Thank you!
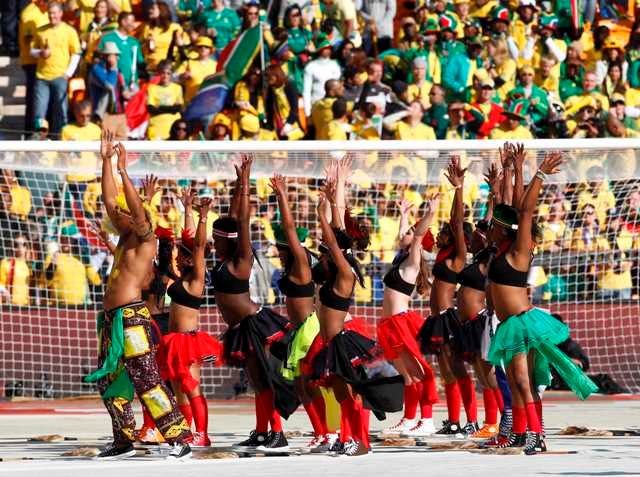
[{"left": 61, "top": 100, "right": 100, "bottom": 190}]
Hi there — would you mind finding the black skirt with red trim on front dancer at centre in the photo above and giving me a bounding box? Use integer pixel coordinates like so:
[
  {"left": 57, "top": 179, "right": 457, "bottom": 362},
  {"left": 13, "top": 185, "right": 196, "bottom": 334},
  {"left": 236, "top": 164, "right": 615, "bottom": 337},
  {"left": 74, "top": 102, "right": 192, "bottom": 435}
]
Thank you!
[{"left": 311, "top": 330, "right": 380, "bottom": 385}]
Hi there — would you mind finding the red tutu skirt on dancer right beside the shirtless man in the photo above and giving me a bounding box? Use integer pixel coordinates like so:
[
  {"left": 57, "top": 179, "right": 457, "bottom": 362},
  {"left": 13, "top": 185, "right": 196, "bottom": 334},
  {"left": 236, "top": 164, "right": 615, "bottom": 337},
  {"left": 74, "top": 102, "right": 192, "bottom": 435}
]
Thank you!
[{"left": 158, "top": 331, "right": 222, "bottom": 394}]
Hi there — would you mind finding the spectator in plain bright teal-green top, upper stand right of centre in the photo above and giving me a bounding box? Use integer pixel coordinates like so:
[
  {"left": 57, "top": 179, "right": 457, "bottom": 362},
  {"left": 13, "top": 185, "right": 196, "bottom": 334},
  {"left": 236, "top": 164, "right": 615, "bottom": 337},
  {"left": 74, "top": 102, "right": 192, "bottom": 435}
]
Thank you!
[{"left": 442, "top": 37, "right": 482, "bottom": 102}]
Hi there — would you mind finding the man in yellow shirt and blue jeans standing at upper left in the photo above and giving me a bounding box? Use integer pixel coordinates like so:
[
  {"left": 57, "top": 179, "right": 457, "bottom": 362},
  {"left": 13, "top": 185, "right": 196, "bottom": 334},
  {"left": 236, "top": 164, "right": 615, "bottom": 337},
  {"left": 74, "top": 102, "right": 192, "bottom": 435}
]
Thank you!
[{"left": 31, "top": 2, "right": 80, "bottom": 134}]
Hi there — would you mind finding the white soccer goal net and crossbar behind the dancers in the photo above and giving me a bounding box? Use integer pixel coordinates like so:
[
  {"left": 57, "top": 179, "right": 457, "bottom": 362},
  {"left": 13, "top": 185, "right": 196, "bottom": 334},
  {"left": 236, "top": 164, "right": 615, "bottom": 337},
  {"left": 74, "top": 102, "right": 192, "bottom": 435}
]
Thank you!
[{"left": 0, "top": 140, "right": 640, "bottom": 398}]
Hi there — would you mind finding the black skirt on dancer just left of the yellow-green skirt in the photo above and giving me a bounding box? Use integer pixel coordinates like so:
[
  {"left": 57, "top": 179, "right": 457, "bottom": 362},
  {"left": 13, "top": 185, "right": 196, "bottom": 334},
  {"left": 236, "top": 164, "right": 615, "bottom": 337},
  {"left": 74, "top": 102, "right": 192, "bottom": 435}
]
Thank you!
[{"left": 223, "top": 307, "right": 290, "bottom": 367}]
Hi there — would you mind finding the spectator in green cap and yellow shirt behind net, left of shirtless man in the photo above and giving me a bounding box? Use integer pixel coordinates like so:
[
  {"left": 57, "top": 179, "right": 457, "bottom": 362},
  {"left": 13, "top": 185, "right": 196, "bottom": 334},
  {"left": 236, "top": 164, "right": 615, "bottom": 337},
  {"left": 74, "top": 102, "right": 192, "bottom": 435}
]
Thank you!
[{"left": 45, "top": 223, "right": 101, "bottom": 306}]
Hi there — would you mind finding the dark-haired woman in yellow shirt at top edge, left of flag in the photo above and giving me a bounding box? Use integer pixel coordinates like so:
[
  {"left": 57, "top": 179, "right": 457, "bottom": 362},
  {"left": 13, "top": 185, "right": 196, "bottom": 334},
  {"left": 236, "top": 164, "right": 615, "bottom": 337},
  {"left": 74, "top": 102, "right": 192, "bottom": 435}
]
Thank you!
[{"left": 140, "top": 1, "right": 184, "bottom": 71}]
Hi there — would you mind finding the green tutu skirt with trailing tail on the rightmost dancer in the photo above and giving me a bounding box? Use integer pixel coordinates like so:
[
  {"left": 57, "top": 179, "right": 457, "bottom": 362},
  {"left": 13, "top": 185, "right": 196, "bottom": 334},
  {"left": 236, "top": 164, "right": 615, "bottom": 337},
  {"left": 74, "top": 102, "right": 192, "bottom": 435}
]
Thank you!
[{"left": 488, "top": 308, "right": 598, "bottom": 399}]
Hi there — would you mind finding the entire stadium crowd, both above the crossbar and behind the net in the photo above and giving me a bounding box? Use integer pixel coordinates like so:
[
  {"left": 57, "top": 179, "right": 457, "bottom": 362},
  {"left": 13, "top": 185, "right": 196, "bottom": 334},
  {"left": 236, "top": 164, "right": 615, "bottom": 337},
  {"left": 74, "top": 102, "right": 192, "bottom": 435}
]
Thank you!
[{"left": 0, "top": 0, "right": 640, "bottom": 306}]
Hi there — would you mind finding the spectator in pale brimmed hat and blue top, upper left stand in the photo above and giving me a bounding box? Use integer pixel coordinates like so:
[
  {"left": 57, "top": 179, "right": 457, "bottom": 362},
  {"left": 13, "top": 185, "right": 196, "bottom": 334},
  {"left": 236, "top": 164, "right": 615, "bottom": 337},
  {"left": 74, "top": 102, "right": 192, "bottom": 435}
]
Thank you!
[{"left": 89, "top": 41, "right": 130, "bottom": 119}]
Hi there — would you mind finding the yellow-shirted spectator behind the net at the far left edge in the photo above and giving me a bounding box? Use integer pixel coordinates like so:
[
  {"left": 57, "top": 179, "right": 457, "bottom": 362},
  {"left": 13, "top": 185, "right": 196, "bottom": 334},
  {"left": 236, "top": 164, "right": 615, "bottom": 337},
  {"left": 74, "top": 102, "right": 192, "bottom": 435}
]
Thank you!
[{"left": 0, "top": 235, "right": 31, "bottom": 306}]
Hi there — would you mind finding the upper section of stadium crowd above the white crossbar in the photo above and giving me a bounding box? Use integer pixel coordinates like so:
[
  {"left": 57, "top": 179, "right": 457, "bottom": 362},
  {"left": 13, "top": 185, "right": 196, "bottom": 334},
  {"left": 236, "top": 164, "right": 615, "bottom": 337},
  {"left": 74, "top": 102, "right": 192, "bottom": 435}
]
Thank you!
[{"left": 2, "top": 0, "right": 640, "bottom": 140}]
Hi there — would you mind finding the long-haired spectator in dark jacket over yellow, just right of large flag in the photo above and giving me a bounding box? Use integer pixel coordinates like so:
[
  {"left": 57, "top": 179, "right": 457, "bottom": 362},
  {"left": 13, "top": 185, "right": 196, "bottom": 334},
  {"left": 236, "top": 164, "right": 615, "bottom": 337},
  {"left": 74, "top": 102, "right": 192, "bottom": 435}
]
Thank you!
[{"left": 265, "top": 64, "right": 304, "bottom": 141}]
